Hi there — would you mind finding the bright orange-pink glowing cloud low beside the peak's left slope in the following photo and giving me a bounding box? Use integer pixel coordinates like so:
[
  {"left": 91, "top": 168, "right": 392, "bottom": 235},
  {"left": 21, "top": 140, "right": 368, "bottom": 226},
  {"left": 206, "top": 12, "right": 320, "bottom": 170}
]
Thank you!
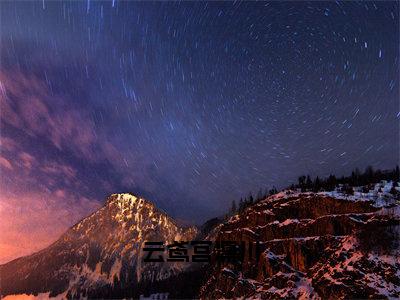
[{"left": 0, "top": 190, "right": 100, "bottom": 264}]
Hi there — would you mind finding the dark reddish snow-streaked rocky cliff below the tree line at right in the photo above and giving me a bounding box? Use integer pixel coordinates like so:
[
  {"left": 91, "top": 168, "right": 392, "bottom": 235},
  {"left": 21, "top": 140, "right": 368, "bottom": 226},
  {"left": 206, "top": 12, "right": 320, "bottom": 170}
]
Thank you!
[{"left": 201, "top": 191, "right": 400, "bottom": 299}]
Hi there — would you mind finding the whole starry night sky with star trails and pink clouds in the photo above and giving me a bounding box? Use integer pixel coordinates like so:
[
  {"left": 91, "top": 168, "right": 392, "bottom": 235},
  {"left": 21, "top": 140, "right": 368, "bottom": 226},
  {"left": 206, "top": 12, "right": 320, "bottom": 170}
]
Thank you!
[{"left": 0, "top": 1, "right": 400, "bottom": 262}]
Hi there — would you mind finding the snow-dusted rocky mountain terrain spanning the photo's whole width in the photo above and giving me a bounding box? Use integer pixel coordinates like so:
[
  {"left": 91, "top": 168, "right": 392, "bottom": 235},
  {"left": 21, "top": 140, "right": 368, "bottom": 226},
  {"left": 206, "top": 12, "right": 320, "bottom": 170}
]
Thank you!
[{"left": 0, "top": 191, "right": 400, "bottom": 299}]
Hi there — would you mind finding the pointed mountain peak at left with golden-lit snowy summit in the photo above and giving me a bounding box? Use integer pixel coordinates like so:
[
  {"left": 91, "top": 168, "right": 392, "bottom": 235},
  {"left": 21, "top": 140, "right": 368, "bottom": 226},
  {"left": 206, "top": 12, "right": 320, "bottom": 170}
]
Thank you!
[{"left": 0, "top": 194, "right": 197, "bottom": 298}]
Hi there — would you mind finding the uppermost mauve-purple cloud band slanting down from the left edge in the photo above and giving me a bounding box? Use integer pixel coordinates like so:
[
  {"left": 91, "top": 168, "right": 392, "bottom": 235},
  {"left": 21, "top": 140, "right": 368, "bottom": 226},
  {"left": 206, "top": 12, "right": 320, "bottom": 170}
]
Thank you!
[{"left": 0, "top": 71, "right": 118, "bottom": 161}]
